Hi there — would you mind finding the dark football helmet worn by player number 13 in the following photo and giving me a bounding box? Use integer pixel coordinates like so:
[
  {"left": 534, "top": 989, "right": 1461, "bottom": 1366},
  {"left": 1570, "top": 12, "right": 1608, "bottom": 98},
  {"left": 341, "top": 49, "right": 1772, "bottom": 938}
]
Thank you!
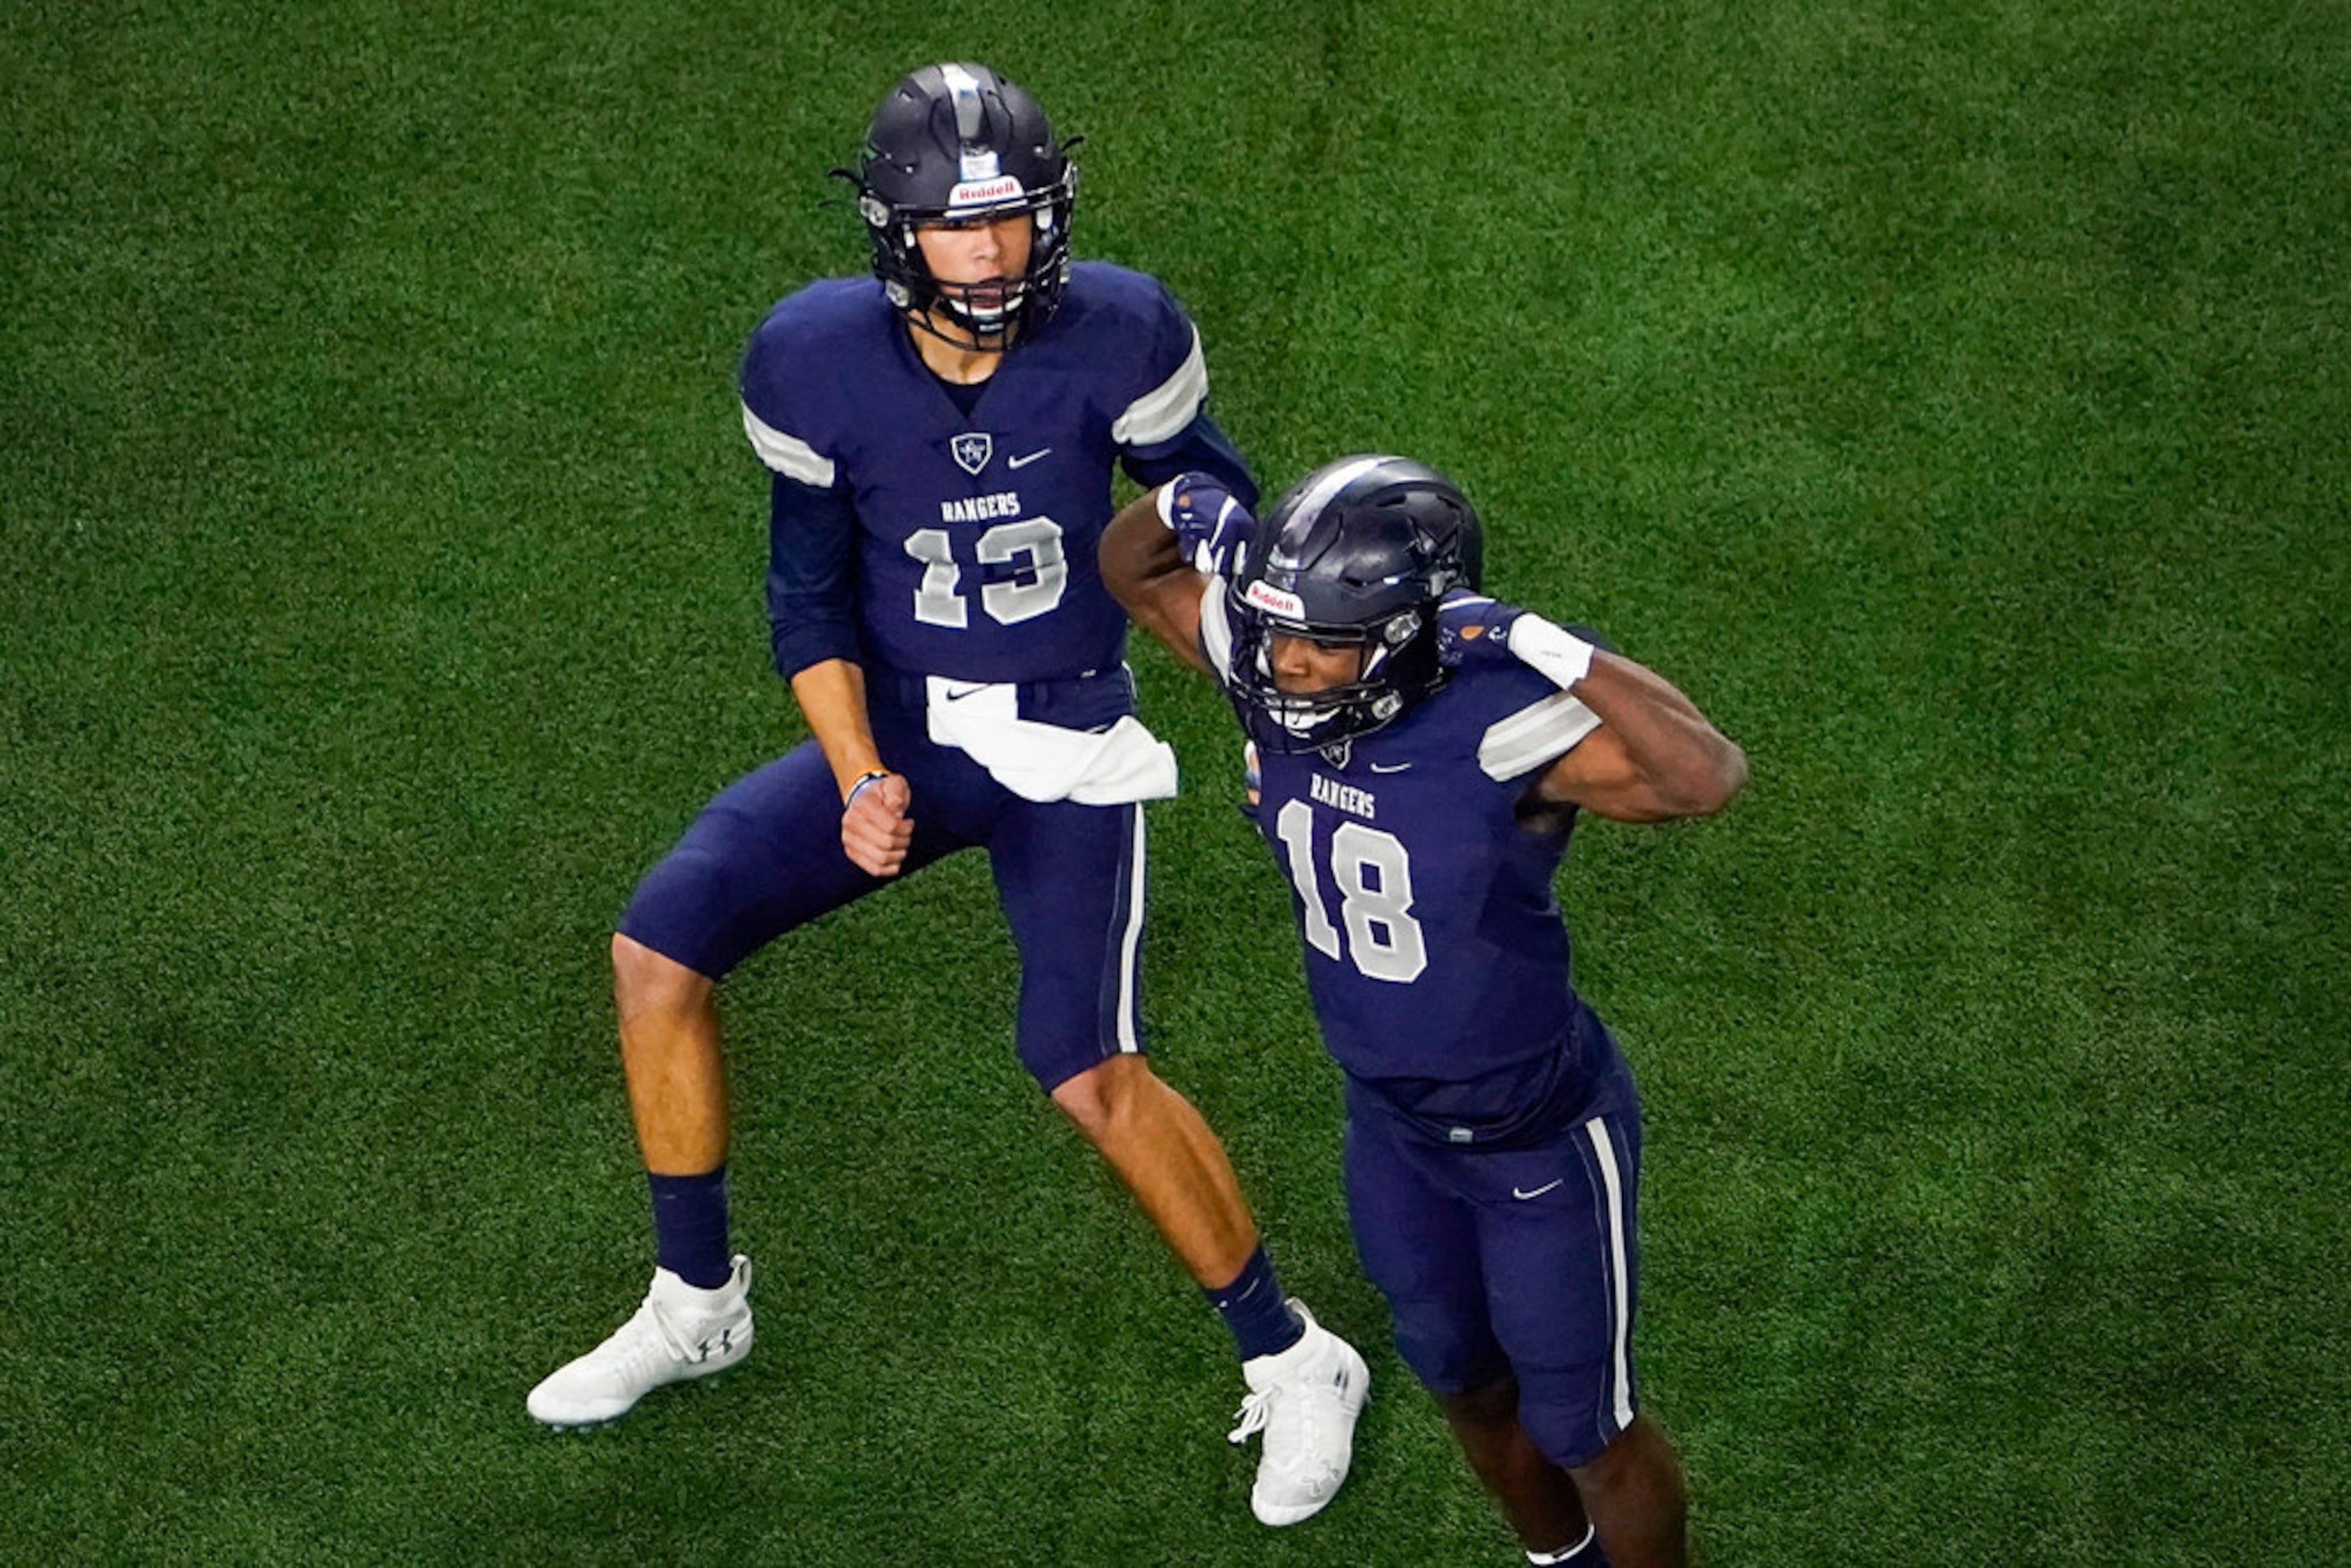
[{"left": 835, "top": 63, "right": 1077, "bottom": 352}]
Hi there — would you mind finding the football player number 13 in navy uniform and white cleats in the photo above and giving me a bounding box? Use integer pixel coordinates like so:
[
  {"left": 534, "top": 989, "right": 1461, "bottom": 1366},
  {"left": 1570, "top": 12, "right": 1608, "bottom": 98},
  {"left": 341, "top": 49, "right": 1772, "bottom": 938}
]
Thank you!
[{"left": 529, "top": 63, "right": 1368, "bottom": 1524}]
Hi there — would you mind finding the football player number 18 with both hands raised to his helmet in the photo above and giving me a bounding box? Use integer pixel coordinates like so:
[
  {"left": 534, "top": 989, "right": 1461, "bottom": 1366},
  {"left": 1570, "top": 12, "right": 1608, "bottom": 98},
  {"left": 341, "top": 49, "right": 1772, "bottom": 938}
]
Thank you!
[{"left": 1103, "top": 456, "right": 1747, "bottom": 1568}]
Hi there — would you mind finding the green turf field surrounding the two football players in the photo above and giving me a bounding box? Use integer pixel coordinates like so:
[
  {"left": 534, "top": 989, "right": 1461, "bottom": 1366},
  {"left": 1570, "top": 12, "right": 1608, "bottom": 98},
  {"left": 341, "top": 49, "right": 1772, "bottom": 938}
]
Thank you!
[{"left": 0, "top": 0, "right": 2351, "bottom": 1568}]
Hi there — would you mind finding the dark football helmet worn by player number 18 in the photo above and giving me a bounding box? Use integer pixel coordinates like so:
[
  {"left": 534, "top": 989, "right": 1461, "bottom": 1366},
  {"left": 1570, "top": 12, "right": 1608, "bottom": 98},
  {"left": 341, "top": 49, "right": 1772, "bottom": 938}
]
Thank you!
[{"left": 1225, "top": 456, "right": 1486, "bottom": 752}]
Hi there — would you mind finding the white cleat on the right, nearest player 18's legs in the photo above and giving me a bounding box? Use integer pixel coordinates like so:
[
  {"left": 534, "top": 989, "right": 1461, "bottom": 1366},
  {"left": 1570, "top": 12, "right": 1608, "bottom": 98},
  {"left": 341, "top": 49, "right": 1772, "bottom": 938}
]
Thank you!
[{"left": 1230, "top": 1295, "right": 1371, "bottom": 1525}]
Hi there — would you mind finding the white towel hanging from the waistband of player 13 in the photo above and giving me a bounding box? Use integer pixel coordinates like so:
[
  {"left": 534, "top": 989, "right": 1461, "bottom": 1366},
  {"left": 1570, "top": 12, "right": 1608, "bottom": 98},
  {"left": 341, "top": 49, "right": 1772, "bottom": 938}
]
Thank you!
[{"left": 914, "top": 675, "right": 1176, "bottom": 811}]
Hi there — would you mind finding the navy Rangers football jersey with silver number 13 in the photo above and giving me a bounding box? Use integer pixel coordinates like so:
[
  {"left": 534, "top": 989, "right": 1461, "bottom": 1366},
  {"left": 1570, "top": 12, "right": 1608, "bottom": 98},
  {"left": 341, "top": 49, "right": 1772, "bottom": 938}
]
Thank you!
[{"left": 741, "top": 263, "right": 1246, "bottom": 682}]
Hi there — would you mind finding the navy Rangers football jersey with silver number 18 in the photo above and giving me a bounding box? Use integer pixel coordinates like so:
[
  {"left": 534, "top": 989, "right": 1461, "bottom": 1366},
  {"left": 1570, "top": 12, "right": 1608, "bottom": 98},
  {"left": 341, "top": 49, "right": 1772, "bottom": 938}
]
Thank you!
[{"left": 1201, "top": 583, "right": 1613, "bottom": 1142}]
